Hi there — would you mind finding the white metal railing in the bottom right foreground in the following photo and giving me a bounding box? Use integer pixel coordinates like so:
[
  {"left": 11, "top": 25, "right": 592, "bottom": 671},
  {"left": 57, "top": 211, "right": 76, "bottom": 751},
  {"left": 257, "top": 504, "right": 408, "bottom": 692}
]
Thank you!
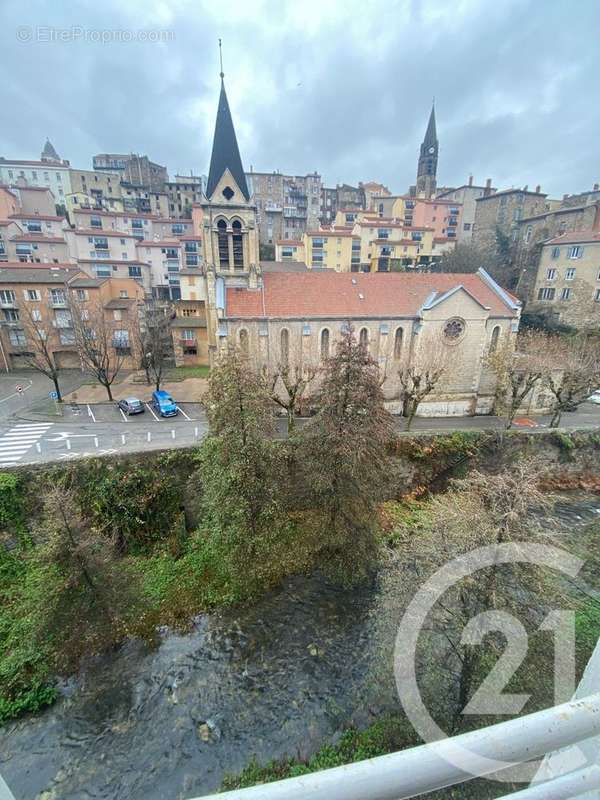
[{"left": 195, "top": 693, "right": 600, "bottom": 800}]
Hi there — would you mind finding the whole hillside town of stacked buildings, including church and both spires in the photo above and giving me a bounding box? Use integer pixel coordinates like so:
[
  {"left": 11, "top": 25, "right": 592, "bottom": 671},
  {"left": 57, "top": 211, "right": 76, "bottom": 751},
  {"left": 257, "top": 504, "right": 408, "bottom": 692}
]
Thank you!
[{"left": 0, "top": 70, "right": 600, "bottom": 432}]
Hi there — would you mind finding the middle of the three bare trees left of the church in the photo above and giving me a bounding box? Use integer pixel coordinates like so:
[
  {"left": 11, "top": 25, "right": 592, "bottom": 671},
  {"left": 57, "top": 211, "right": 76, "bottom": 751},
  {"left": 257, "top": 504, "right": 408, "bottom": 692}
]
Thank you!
[{"left": 68, "top": 292, "right": 131, "bottom": 400}]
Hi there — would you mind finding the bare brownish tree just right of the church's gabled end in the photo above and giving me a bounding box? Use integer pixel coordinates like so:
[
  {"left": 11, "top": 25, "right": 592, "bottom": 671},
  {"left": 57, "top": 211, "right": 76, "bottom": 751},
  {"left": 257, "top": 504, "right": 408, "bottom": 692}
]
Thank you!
[{"left": 485, "top": 330, "right": 548, "bottom": 430}]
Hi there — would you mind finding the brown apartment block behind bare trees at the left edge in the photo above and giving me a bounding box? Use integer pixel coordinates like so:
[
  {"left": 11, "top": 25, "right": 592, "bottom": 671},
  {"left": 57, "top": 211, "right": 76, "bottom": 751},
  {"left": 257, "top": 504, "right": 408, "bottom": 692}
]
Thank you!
[{"left": 0, "top": 263, "right": 143, "bottom": 369}]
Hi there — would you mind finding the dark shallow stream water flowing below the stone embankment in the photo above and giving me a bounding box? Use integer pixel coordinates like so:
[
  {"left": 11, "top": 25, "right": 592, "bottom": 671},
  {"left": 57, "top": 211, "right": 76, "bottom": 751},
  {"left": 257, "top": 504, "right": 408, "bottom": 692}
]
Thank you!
[{"left": 0, "top": 495, "right": 600, "bottom": 800}]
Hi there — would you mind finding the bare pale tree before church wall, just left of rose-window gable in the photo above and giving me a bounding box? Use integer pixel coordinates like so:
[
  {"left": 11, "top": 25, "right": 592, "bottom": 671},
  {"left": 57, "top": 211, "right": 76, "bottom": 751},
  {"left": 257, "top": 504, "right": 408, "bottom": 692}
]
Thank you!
[{"left": 398, "top": 337, "right": 448, "bottom": 431}]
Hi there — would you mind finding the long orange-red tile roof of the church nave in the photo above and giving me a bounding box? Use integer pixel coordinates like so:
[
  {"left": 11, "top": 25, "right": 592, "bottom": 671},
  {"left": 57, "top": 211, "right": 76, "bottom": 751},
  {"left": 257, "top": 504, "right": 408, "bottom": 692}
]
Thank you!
[{"left": 225, "top": 271, "right": 516, "bottom": 319}]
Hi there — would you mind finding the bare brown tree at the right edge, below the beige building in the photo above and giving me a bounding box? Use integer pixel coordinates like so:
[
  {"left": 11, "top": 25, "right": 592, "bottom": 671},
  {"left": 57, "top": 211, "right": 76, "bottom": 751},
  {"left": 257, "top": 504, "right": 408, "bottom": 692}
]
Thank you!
[{"left": 542, "top": 336, "right": 600, "bottom": 428}]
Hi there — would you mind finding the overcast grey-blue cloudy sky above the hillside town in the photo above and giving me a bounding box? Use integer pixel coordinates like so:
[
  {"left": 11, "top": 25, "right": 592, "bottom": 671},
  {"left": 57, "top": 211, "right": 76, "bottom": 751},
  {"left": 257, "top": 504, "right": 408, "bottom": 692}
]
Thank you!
[{"left": 0, "top": 0, "right": 600, "bottom": 196}]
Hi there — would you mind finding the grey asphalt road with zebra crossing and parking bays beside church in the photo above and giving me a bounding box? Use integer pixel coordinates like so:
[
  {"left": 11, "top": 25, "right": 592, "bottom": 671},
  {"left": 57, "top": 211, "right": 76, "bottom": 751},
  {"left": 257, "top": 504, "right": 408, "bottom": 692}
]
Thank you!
[{"left": 0, "top": 403, "right": 600, "bottom": 468}]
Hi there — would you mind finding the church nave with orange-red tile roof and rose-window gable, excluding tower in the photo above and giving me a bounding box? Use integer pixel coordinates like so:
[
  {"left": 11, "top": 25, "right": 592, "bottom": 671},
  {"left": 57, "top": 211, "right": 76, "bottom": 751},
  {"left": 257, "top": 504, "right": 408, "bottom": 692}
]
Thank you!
[{"left": 219, "top": 270, "right": 520, "bottom": 416}]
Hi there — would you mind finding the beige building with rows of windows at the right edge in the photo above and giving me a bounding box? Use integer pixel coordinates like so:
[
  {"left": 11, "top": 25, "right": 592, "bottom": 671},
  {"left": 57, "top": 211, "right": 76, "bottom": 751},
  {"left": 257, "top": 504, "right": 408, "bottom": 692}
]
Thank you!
[{"left": 527, "top": 230, "right": 600, "bottom": 329}]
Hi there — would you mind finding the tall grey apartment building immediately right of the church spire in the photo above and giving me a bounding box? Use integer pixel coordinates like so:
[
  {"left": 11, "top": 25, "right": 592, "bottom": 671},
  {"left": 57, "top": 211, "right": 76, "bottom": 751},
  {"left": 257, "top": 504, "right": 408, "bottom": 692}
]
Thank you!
[{"left": 246, "top": 171, "right": 321, "bottom": 244}]
